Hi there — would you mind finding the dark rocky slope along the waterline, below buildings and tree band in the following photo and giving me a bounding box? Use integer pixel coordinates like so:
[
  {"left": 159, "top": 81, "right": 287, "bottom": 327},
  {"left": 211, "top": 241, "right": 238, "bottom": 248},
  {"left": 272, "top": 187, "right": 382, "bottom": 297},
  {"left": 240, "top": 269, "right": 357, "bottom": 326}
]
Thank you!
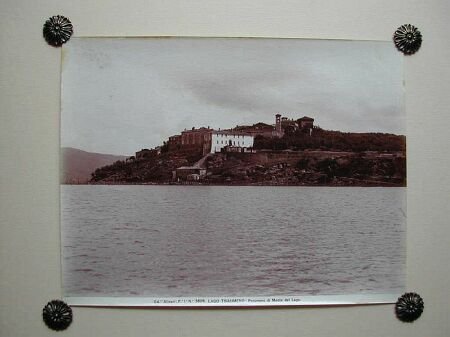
[{"left": 89, "top": 150, "right": 406, "bottom": 187}]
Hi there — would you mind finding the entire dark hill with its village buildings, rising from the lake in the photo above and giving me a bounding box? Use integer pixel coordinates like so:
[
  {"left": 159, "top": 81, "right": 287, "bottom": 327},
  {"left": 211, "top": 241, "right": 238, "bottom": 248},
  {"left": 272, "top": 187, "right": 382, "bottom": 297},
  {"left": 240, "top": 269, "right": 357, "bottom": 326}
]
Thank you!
[{"left": 90, "top": 114, "right": 406, "bottom": 186}]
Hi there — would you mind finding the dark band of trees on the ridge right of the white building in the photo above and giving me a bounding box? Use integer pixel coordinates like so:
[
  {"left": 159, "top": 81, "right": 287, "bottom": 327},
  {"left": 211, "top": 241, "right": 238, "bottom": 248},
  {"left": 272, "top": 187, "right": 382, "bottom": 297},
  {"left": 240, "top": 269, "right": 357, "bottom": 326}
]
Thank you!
[{"left": 253, "top": 127, "right": 406, "bottom": 152}]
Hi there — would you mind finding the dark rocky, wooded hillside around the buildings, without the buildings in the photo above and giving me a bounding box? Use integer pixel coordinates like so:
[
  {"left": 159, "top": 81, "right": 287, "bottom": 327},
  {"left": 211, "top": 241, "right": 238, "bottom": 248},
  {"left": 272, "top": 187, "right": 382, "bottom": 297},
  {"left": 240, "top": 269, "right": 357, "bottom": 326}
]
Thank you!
[{"left": 90, "top": 123, "right": 406, "bottom": 186}]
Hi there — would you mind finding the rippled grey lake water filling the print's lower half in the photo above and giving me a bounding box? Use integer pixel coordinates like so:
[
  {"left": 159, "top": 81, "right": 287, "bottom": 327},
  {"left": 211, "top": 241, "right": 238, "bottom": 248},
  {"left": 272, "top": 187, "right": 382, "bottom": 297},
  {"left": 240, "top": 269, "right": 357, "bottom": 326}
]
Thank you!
[{"left": 61, "top": 185, "right": 406, "bottom": 297}]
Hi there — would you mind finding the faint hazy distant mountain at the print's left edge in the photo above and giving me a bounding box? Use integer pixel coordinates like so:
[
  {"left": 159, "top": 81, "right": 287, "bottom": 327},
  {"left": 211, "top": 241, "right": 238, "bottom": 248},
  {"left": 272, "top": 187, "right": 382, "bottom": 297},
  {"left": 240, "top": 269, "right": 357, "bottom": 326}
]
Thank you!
[{"left": 61, "top": 147, "right": 127, "bottom": 184}]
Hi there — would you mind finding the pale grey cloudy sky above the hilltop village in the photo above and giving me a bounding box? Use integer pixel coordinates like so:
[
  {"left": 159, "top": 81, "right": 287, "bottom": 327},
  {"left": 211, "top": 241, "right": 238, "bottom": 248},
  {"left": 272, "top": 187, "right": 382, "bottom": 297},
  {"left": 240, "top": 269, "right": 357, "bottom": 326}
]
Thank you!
[{"left": 61, "top": 38, "right": 406, "bottom": 156}]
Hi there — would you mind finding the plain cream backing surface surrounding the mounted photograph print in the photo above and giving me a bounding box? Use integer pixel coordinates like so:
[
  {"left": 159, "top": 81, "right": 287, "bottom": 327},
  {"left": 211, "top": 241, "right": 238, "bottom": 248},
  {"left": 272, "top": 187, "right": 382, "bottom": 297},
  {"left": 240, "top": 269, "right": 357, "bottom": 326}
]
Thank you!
[{"left": 0, "top": 0, "right": 450, "bottom": 337}]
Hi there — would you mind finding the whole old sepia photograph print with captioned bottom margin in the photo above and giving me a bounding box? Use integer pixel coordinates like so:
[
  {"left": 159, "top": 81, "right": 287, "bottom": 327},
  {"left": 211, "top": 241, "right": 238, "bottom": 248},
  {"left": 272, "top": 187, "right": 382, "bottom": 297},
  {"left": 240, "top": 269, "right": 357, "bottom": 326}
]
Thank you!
[{"left": 61, "top": 38, "right": 406, "bottom": 306}]
